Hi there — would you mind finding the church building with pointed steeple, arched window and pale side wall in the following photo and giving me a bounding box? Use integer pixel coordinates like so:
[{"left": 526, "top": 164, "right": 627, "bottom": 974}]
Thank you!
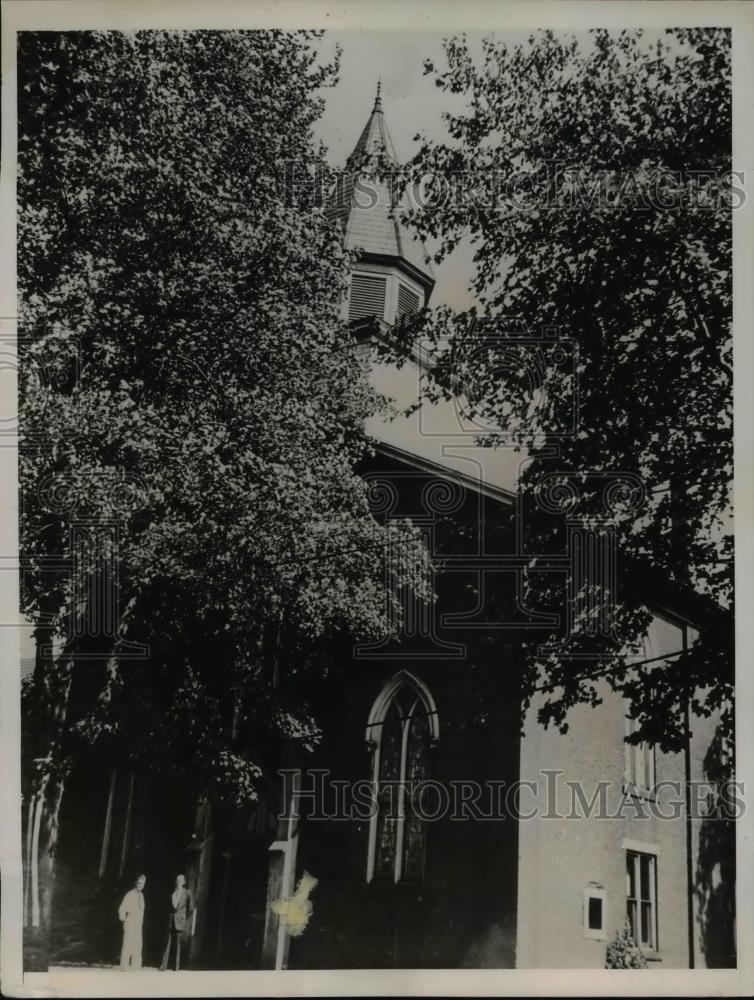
[{"left": 27, "top": 82, "right": 735, "bottom": 969}]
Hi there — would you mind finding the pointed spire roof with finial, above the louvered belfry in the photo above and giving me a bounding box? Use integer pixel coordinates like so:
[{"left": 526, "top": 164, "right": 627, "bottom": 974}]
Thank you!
[{"left": 329, "top": 81, "right": 435, "bottom": 291}]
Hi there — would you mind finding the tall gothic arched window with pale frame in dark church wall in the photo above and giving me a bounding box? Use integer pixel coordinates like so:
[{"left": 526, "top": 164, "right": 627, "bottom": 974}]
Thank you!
[{"left": 367, "top": 670, "right": 439, "bottom": 882}]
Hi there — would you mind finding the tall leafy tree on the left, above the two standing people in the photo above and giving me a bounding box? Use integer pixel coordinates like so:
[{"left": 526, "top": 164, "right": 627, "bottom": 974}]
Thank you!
[{"left": 18, "top": 31, "right": 427, "bottom": 964}]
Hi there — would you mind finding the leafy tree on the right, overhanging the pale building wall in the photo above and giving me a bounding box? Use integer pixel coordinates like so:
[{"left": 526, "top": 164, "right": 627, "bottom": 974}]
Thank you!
[{"left": 402, "top": 29, "right": 741, "bottom": 749}]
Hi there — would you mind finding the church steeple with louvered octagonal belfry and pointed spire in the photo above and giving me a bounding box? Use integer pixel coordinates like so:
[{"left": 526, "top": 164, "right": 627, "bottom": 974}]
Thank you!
[{"left": 329, "top": 80, "right": 435, "bottom": 323}]
